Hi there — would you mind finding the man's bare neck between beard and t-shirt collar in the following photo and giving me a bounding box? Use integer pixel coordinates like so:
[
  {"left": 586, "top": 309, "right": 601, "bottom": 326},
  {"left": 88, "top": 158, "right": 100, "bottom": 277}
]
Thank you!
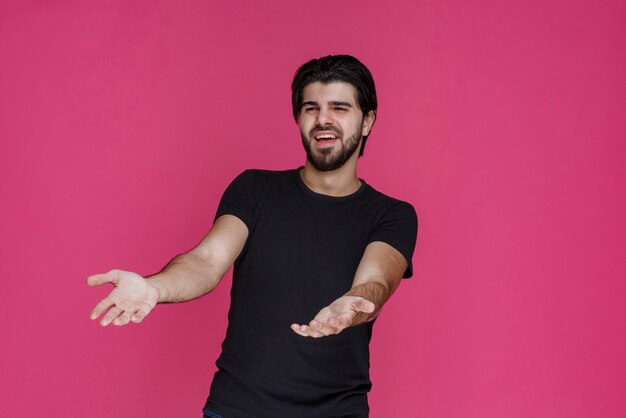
[{"left": 300, "top": 161, "right": 361, "bottom": 197}]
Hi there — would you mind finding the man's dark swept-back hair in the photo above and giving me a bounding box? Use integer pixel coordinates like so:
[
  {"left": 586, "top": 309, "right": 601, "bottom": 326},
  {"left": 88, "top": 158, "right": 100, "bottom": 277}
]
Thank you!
[{"left": 291, "top": 55, "right": 378, "bottom": 156}]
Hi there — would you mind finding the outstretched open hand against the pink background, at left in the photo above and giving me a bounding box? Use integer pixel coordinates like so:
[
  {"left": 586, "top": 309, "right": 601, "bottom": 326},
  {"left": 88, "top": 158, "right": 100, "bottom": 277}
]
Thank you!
[{"left": 87, "top": 270, "right": 159, "bottom": 327}]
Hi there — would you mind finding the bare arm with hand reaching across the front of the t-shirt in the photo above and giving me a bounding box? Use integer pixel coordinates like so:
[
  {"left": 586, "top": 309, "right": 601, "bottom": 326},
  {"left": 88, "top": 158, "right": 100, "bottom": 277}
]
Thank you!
[{"left": 291, "top": 241, "right": 407, "bottom": 338}]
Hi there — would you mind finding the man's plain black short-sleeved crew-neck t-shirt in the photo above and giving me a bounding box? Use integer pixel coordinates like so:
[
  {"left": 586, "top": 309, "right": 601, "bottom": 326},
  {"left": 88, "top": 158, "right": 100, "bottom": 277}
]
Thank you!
[{"left": 205, "top": 169, "right": 417, "bottom": 418}]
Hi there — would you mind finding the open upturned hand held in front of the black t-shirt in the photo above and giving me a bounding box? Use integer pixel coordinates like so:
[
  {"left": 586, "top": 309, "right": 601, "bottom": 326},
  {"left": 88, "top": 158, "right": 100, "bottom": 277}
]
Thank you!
[{"left": 291, "top": 296, "right": 376, "bottom": 338}]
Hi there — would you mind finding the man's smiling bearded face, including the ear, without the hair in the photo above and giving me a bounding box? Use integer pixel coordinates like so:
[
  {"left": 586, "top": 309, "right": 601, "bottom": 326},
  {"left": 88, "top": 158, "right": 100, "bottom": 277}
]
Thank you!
[{"left": 299, "top": 81, "right": 373, "bottom": 171}]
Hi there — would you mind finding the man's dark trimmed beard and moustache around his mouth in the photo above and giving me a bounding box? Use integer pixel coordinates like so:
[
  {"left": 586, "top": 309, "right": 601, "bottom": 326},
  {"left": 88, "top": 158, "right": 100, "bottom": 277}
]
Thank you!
[{"left": 300, "top": 124, "right": 363, "bottom": 171}]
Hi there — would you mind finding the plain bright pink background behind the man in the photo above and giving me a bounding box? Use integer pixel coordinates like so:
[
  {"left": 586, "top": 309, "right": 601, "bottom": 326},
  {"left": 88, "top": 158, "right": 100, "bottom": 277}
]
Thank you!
[{"left": 0, "top": 0, "right": 626, "bottom": 418}]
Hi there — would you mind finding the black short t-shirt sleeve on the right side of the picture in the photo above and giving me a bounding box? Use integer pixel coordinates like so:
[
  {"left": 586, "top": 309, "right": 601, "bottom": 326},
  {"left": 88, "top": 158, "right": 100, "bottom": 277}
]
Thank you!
[{"left": 368, "top": 201, "right": 417, "bottom": 278}]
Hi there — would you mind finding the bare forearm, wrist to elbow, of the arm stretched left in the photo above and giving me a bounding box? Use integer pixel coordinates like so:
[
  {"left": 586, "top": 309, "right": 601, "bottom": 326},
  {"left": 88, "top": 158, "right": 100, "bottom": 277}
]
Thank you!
[{"left": 147, "top": 252, "right": 225, "bottom": 303}]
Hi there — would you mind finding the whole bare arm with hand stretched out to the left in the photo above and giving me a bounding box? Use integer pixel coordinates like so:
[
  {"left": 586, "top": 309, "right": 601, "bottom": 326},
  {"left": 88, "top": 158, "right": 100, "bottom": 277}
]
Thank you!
[{"left": 87, "top": 215, "right": 248, "bottom": 326}]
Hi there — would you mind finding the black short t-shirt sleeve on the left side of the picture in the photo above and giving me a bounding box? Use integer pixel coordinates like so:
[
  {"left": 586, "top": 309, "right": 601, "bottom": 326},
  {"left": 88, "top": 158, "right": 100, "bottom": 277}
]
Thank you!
[{"left": 215, "top": 170, "right": 256, "bottom": 231}]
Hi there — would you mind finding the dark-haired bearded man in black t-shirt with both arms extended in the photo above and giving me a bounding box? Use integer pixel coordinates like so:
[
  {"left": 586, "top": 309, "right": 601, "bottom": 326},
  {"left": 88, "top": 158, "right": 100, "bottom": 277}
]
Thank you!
[{"left": 88, "top": 55, "right": 417, "bottom": 418}]
